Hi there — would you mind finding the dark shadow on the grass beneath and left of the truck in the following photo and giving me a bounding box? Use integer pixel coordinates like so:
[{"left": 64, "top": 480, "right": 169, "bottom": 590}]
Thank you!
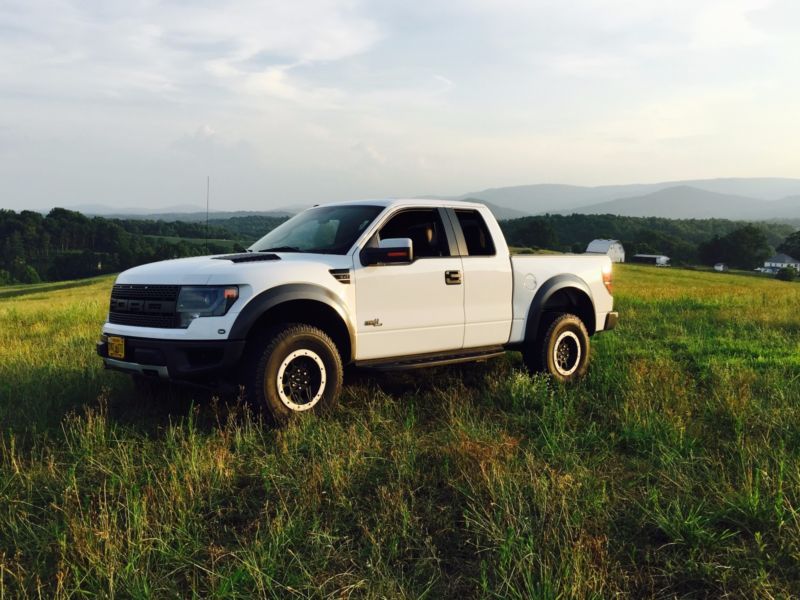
[{"left": 0, "top": 355, "right": 519, "bottom": 440}]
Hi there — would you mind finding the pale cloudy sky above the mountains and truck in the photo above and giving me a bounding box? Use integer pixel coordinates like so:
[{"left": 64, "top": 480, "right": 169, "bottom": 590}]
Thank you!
[{"left": 0, "top": 0, "right": 800, "bottom": 210}]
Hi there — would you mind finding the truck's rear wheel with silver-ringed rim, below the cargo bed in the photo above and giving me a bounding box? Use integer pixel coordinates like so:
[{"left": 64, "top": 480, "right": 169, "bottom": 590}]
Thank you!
[{"left": 523, "top": 313, "right": 589, "bottom": 383}]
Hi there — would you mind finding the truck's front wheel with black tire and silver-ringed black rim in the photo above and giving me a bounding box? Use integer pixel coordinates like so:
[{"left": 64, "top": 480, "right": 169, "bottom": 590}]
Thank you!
[{"left": 245, "top": 323, "right": 343, "bottom": 424}]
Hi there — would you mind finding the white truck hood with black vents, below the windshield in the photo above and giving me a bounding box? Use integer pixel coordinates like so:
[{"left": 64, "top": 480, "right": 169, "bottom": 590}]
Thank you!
[{"left": 117, "top": 252, "right": 352, "bottom": 285}]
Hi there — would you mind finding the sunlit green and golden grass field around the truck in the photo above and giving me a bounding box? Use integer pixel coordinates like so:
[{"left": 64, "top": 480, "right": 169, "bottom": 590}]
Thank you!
[{"left": 0, "top": 266, "right": 800, "bottom": 598}]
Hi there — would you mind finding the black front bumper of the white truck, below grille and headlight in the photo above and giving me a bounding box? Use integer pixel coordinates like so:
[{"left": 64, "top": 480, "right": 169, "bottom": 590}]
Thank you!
[{"left": 97, "top": 334, "right": 245, "bottom": 381}]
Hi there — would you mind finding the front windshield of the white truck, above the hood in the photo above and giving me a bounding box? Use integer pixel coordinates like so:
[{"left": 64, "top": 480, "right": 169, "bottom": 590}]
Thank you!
[{"left": 250, "top": 204, "right": 384, "bottom": 254}]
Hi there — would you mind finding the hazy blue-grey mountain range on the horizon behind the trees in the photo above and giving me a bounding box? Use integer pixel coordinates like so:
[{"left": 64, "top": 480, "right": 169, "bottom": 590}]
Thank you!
[{"left": 59, "top": 177, "right": 800, "bottom": 224}]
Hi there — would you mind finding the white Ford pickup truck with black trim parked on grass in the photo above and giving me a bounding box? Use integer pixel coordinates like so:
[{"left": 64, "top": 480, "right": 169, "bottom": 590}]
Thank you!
[{"left": 97, "top": 200, "right": 617, "bottom": 421}]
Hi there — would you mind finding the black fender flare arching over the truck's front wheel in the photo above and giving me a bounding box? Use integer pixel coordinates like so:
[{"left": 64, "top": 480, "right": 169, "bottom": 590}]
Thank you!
[{"left": 229, "top": 283, "right": 356, "bottom": 360}]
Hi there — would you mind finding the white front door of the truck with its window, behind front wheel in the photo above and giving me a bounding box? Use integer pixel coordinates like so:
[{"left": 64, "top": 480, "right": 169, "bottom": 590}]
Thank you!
[{"left": 354, "top": 208, "right": 464, "bottom": 360}]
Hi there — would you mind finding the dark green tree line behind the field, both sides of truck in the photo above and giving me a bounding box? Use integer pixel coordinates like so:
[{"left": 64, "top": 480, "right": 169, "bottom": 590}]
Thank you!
[{"left": 0, "top": 208, "right": 800, "bottom": 285}]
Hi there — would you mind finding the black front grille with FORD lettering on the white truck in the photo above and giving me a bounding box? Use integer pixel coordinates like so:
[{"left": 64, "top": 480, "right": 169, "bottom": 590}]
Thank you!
[{"left": 108, "top": 284, "right": 181, "bottom": 329}]
